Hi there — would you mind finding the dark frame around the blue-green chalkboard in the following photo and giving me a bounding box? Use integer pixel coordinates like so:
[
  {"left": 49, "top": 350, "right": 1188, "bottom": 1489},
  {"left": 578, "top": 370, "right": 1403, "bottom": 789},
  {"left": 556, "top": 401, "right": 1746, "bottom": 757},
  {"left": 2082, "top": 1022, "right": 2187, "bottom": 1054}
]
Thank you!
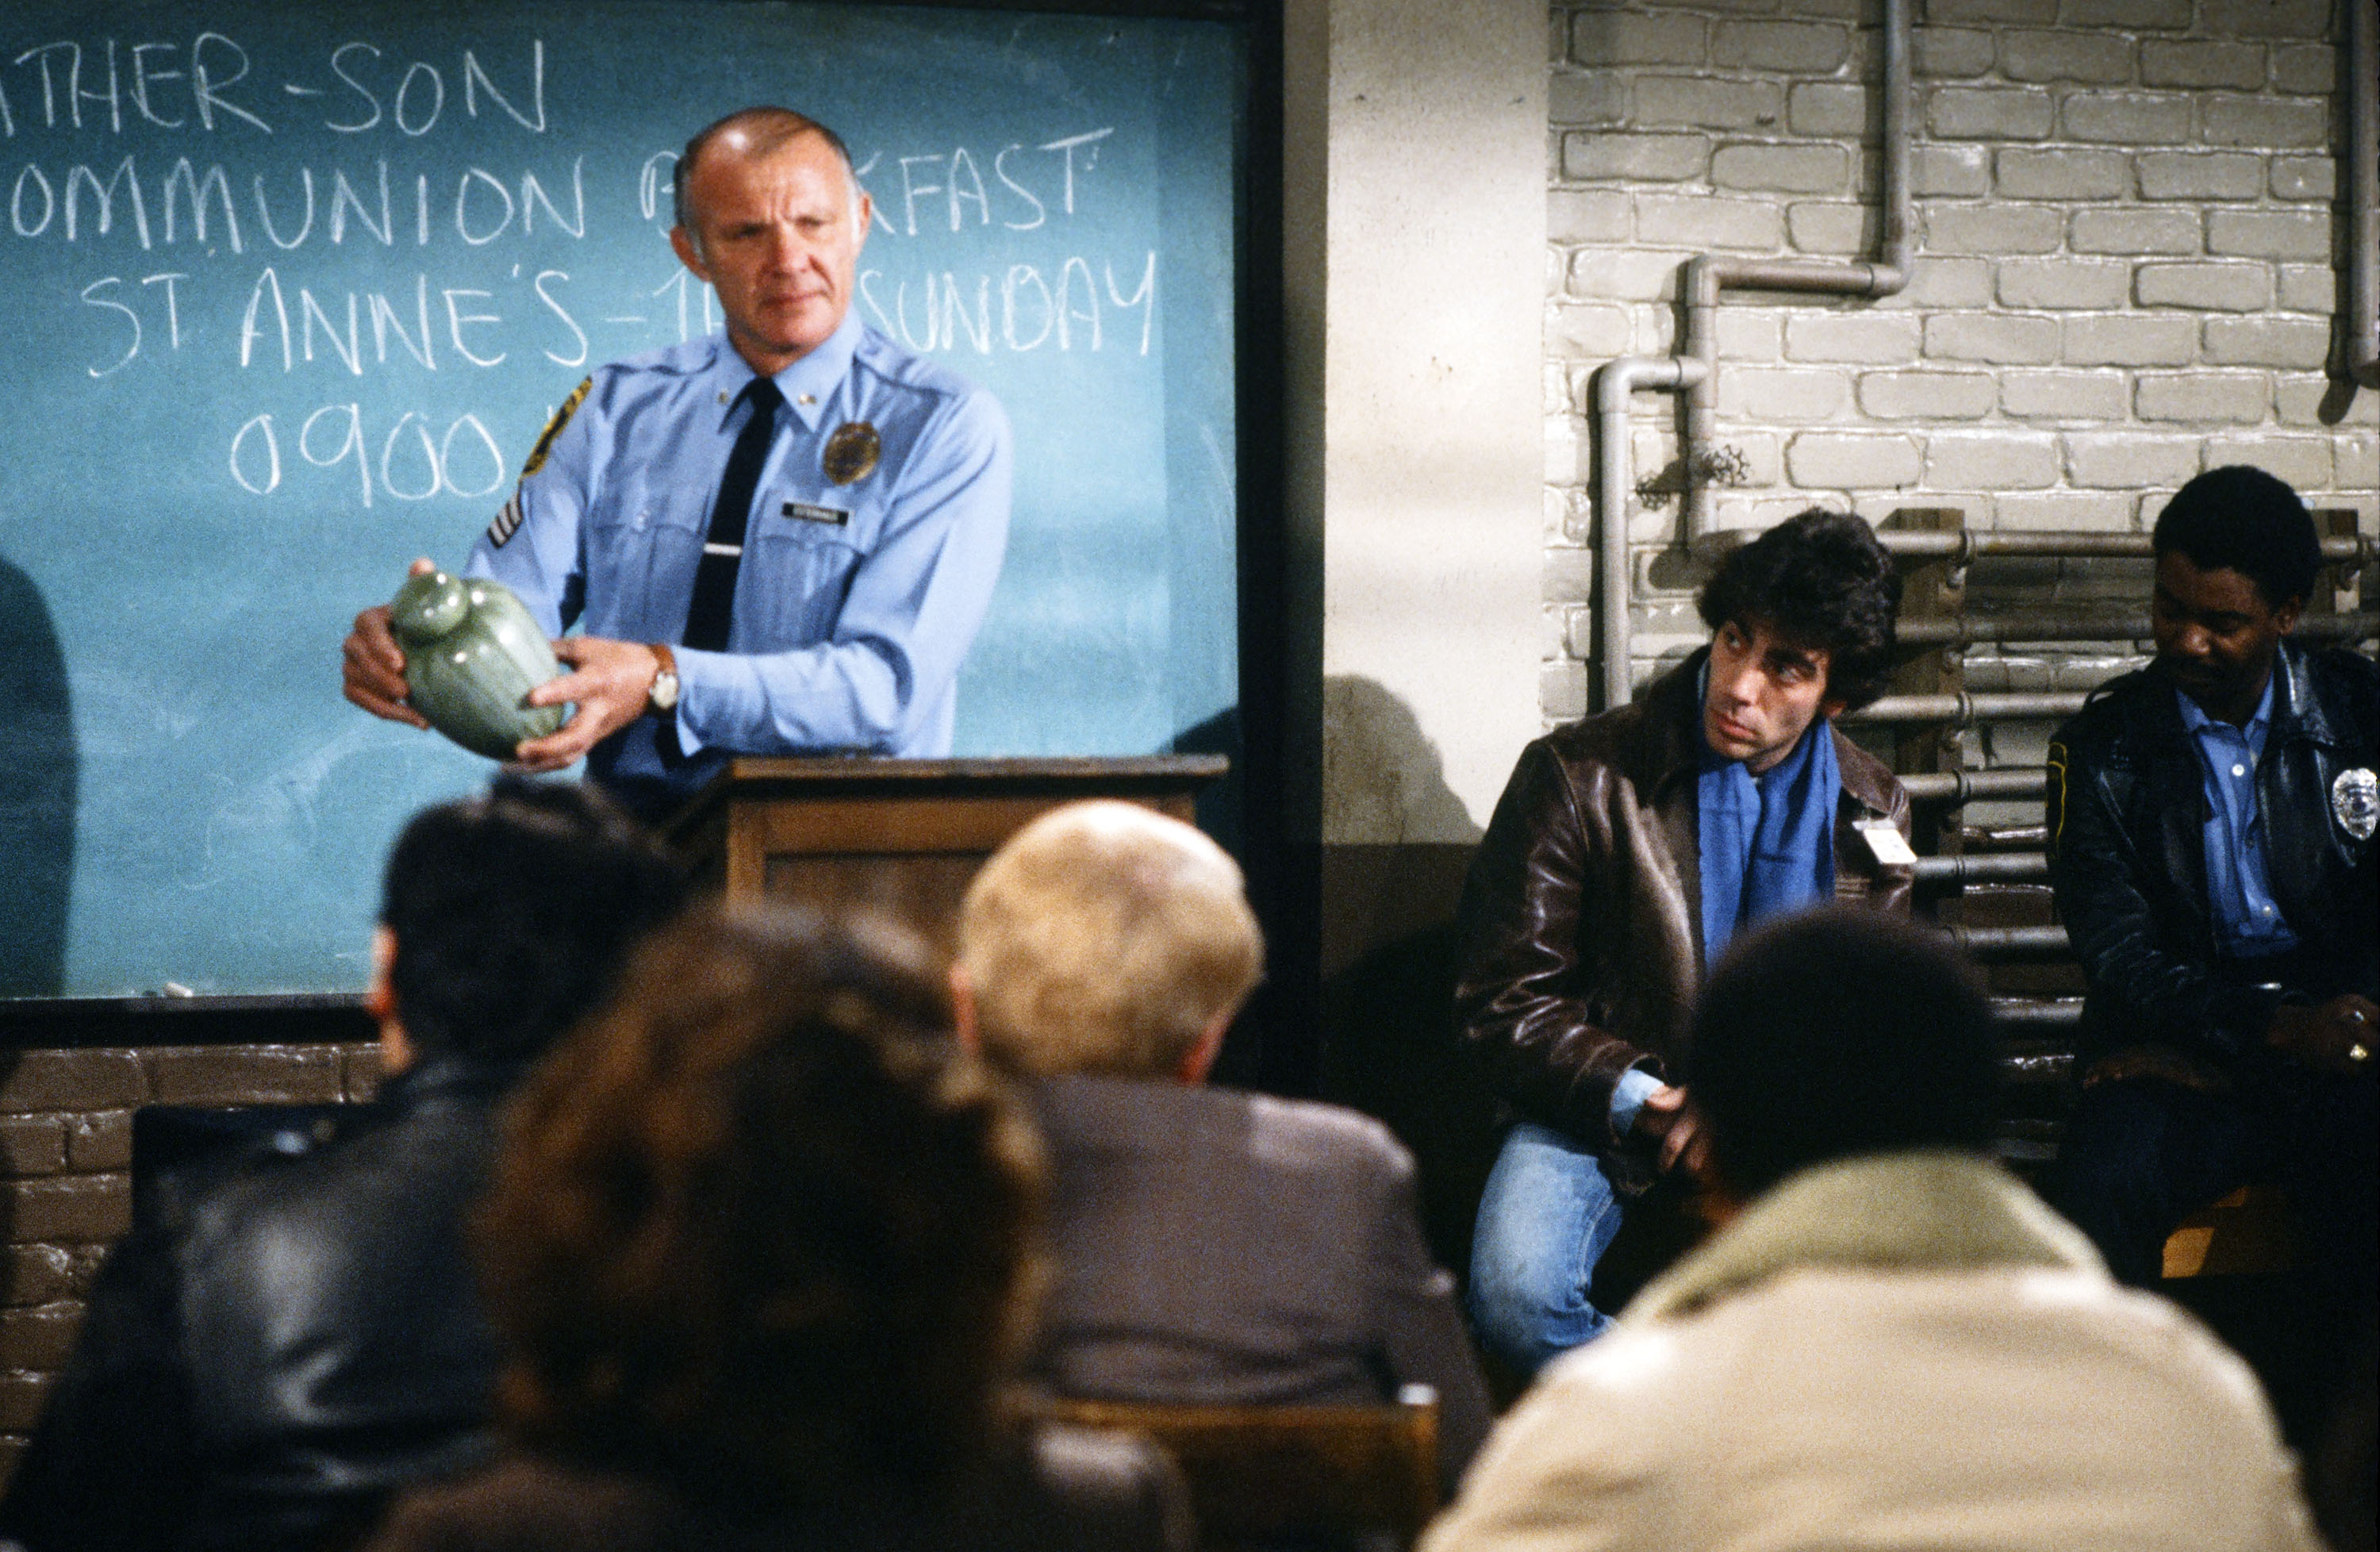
[{"left": 0, "top": 0, "right": 1321, "bottom": 1066}]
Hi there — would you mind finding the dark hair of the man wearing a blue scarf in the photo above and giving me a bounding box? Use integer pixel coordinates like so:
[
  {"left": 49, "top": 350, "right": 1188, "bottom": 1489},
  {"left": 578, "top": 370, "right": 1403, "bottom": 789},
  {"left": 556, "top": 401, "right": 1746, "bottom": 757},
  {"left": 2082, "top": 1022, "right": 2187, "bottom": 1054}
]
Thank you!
[{"left": 1697, "top": 507, "right": 1902, "bottom": 712}]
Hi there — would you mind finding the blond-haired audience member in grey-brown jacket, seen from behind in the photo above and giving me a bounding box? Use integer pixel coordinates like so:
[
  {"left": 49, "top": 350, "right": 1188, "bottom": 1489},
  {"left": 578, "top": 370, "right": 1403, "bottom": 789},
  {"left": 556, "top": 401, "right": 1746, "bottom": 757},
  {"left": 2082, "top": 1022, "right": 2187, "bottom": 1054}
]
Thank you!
[{"left": 952, "top": 802, "right": 1488, "bottom": 1478}]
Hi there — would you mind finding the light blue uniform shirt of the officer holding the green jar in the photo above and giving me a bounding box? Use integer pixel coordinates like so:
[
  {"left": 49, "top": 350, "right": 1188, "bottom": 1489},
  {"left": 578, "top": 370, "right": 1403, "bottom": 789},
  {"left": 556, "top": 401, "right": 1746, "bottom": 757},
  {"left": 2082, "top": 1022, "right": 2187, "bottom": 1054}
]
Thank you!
[{"left": 464, "top": 312, "right": 1012, "bottom": 807}]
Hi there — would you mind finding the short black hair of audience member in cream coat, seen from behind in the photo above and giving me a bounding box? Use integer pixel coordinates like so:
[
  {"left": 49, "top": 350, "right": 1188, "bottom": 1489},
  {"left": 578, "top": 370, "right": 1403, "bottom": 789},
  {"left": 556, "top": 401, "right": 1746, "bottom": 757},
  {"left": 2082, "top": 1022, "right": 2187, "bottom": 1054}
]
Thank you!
[{"left": 1687, "top": 907, "right": 1999, "bottom": 1202}]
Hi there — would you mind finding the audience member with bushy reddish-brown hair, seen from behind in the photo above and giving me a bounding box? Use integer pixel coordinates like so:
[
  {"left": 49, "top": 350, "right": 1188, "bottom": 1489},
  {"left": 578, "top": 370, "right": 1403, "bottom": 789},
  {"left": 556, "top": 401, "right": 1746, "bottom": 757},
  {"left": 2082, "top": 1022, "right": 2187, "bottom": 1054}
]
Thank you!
[{"left": 371, "top": 912, "right": 1190, "bottom": 1552}]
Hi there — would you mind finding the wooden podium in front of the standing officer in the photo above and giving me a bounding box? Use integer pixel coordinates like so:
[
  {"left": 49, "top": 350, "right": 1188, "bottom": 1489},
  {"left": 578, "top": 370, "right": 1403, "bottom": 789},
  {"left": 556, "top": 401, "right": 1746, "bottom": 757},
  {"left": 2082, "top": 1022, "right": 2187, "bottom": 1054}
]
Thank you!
[{"left": 664, "top": 755, "right": 1230, "bottom": 952}]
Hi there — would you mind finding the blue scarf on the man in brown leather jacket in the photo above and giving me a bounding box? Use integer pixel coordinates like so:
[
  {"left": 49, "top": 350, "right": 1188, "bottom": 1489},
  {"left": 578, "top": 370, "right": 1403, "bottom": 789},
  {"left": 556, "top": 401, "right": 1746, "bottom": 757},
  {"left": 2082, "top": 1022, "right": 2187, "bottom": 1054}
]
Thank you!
[{"left": 1695, "top": 695, "right": 1842, "bottom": 969}]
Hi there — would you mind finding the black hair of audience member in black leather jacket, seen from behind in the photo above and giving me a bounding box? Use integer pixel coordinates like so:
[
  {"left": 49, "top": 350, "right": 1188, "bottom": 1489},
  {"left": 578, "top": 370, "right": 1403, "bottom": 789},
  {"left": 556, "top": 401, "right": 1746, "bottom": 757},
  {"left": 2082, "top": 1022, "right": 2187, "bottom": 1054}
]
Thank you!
[{"left": 381, "top": 776, "right": 685, "bottom": 1062}]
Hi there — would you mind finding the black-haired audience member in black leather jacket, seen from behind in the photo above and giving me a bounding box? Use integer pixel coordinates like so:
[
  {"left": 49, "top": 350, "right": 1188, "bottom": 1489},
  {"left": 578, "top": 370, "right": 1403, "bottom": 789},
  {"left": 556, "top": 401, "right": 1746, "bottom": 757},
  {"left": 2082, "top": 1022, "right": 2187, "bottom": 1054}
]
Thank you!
[{"left": 0, "top": 781, "right": 683, "bottom": 1552}]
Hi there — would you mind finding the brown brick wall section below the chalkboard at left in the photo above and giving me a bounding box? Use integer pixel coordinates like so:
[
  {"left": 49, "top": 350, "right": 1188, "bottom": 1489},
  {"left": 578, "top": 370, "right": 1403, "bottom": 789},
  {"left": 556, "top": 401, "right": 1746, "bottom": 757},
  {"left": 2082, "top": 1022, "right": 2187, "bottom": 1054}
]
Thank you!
[{"left": 0, "top": 1045, "right": 381, "bottom": 1483}]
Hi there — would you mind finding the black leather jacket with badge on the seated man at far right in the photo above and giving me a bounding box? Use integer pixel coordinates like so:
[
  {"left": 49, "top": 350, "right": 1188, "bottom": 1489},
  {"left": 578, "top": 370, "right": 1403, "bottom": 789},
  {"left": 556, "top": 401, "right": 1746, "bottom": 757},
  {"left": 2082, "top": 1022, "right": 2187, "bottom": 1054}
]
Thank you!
[{"left": 2049, "top": 640, "right": 2380, "bottom": 1076}]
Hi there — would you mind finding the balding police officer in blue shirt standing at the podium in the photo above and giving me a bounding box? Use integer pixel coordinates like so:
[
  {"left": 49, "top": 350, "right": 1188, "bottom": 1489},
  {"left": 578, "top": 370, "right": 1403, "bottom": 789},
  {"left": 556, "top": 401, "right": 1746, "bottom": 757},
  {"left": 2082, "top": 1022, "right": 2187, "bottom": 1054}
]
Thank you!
[{"left": 343, "top": 107, "right": 1012, "bottom": 816}]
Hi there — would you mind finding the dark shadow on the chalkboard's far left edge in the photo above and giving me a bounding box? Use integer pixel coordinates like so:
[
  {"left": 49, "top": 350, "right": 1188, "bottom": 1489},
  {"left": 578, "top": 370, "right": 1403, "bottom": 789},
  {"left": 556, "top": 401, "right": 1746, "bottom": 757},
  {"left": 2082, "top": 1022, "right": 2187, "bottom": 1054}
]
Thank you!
[{"left": 0, "top": 557, "right": 81, "bottom": 997}]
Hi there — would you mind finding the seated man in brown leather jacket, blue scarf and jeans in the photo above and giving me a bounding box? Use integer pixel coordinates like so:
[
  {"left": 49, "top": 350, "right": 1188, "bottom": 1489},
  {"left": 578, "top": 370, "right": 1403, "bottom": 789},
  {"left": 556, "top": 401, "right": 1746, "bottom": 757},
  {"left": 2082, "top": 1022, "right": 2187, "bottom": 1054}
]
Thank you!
[{"left": 1457, "top": 509, "right": 1914, "bottom": 1373}]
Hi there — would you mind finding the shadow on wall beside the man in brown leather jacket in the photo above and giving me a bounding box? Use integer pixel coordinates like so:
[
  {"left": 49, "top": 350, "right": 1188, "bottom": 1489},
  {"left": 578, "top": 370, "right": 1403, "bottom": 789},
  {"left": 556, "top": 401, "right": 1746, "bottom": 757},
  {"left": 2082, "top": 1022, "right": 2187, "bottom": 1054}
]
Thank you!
[{"left": 1319, "top": 678, "right": 1518, "bottom": 1273}]
